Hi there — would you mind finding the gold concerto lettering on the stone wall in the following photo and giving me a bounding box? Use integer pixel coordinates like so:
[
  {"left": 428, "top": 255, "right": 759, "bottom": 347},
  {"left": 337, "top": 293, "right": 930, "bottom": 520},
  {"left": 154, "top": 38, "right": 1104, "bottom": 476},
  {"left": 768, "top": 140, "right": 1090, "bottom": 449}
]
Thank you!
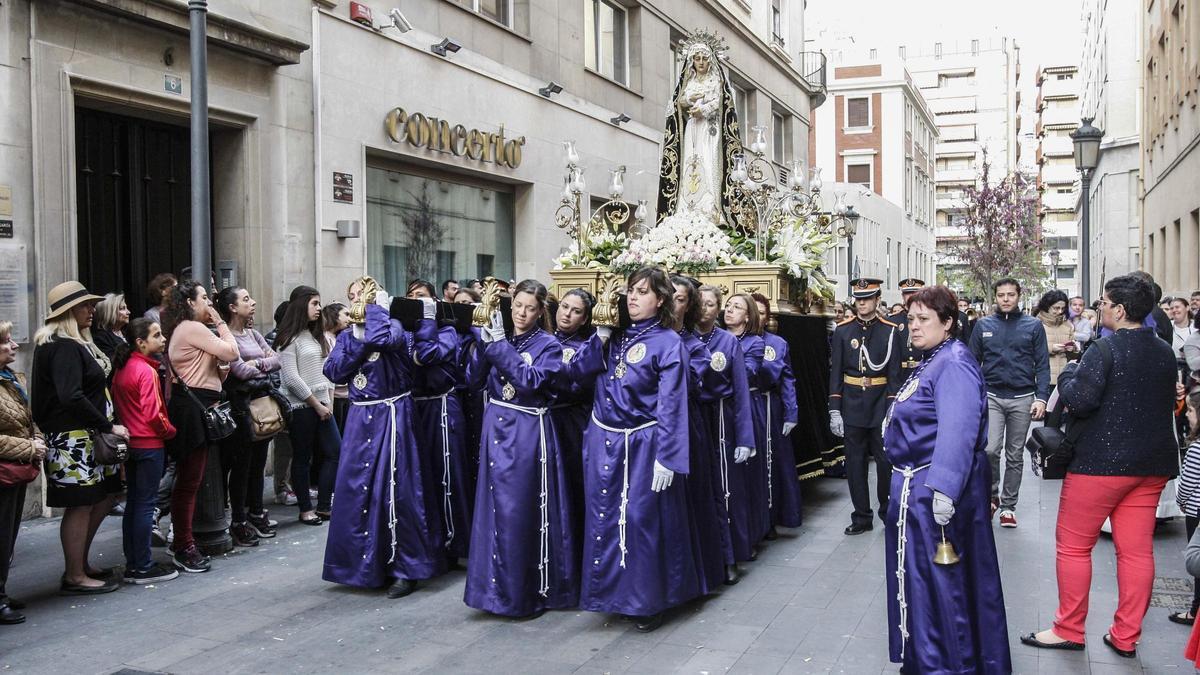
[{"left": 384, "top": 108, "right": 526, "bottom": 168}]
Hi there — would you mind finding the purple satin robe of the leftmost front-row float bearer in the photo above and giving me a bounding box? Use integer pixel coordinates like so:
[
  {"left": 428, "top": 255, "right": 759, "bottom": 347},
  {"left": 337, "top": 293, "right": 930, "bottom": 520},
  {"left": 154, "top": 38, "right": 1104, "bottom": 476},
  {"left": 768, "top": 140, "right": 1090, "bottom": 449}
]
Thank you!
[{"left": 322, "top": 305, "right": 445, "bottom": 589}]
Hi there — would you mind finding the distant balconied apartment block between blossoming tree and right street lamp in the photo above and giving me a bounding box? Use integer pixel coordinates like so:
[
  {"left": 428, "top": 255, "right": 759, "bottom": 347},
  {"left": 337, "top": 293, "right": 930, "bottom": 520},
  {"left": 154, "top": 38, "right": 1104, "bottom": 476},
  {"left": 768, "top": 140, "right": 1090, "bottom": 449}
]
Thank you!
[{"left": 1034, "top": 65, "right": 1081, "bottom": 295}]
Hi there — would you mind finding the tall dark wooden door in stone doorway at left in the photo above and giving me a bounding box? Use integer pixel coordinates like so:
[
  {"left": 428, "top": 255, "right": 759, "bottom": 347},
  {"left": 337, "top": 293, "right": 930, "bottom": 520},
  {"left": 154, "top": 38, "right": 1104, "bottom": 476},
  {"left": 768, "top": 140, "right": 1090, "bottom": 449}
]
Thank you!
[{"left": 76, "top": 108, "right": 192, "bottom": 316}]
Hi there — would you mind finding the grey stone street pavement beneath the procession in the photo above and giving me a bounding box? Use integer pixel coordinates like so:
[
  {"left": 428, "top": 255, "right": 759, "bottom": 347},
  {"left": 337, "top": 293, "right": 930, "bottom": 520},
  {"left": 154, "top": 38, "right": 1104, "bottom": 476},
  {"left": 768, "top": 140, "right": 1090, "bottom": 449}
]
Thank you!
[{"left": 0, "top": 461, "right": 1192, "bottom": 675}]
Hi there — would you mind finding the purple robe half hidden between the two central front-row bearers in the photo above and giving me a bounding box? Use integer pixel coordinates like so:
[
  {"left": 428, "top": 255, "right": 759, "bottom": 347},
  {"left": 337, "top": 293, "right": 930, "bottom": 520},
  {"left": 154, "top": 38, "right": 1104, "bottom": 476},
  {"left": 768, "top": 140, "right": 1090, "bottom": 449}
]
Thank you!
[{"left": 550, "top": 333, "right": 604, "bottom": 545}]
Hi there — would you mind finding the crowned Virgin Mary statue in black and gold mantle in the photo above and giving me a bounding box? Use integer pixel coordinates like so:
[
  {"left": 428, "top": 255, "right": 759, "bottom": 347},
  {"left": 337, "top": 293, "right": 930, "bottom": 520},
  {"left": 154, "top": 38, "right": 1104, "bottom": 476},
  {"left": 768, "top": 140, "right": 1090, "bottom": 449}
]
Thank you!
[{"left": 658, "top": 30, "right": 742, "bottom": 228}]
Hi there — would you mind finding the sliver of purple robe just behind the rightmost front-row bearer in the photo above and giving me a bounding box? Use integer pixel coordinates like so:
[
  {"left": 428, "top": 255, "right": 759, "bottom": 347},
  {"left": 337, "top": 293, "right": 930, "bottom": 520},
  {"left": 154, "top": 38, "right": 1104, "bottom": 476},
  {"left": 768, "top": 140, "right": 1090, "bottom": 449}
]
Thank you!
[{"left": 676, "top": 330, "right": 733, "bottom": 595}]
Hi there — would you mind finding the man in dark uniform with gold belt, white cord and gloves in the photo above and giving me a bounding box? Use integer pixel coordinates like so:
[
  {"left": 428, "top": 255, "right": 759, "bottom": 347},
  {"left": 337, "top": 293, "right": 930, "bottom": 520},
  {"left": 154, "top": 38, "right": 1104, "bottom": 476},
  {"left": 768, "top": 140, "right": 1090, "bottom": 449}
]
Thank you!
[{"left": 829, "top": 279, "right": 901, "bottom": 534}]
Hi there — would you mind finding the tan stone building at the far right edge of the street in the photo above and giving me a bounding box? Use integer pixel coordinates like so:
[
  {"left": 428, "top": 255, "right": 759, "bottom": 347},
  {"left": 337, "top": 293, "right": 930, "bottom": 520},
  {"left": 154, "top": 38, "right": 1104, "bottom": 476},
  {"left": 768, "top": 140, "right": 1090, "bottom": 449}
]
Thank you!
[{"left": 1141, "top": 0, "right": 1200, "bottom": 294}]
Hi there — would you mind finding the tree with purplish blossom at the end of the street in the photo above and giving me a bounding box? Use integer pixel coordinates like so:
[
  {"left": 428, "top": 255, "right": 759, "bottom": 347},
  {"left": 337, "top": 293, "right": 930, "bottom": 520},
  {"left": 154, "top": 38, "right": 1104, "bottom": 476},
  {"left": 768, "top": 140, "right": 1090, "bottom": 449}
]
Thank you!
[{"left": 949, "top": 153, "right": 1045, "bottom": 298}]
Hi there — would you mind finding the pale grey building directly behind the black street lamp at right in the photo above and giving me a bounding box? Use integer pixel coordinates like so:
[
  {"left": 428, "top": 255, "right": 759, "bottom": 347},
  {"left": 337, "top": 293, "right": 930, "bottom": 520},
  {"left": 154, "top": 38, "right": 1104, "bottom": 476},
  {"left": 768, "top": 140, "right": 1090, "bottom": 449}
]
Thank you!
[{"left": 1076, "top": 0, "right": 1142, "bottom": 300}]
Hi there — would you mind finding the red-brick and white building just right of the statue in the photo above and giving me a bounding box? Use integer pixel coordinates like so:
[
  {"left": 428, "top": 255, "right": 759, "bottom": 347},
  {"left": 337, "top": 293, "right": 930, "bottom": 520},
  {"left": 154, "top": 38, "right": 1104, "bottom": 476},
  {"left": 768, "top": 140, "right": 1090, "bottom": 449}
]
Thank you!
[{"left": 809, "top": 56, "right": 937, "bottom": 297}]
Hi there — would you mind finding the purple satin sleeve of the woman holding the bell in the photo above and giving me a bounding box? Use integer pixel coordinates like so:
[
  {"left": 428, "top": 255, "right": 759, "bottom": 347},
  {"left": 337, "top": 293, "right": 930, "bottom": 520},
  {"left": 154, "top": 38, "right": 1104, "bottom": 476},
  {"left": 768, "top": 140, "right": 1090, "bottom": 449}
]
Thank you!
[{"left": 925, "top": 359, "right": 986, "bottom": 503}]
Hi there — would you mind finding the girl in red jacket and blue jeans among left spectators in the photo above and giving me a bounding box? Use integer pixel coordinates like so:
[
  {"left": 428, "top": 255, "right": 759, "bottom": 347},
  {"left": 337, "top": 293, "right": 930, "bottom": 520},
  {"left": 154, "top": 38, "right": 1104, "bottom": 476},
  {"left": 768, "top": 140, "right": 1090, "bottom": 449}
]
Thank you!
[{"left": 113, "top": 318, "right": 179, "bottom": 584}]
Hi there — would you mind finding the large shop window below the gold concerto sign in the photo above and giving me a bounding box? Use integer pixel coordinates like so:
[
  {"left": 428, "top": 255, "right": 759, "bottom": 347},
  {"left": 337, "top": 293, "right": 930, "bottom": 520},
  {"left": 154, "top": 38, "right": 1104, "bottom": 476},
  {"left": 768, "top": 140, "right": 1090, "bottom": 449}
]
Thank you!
[{"left": 366, "top": 167, "right": 515, "bottom": 293}]
